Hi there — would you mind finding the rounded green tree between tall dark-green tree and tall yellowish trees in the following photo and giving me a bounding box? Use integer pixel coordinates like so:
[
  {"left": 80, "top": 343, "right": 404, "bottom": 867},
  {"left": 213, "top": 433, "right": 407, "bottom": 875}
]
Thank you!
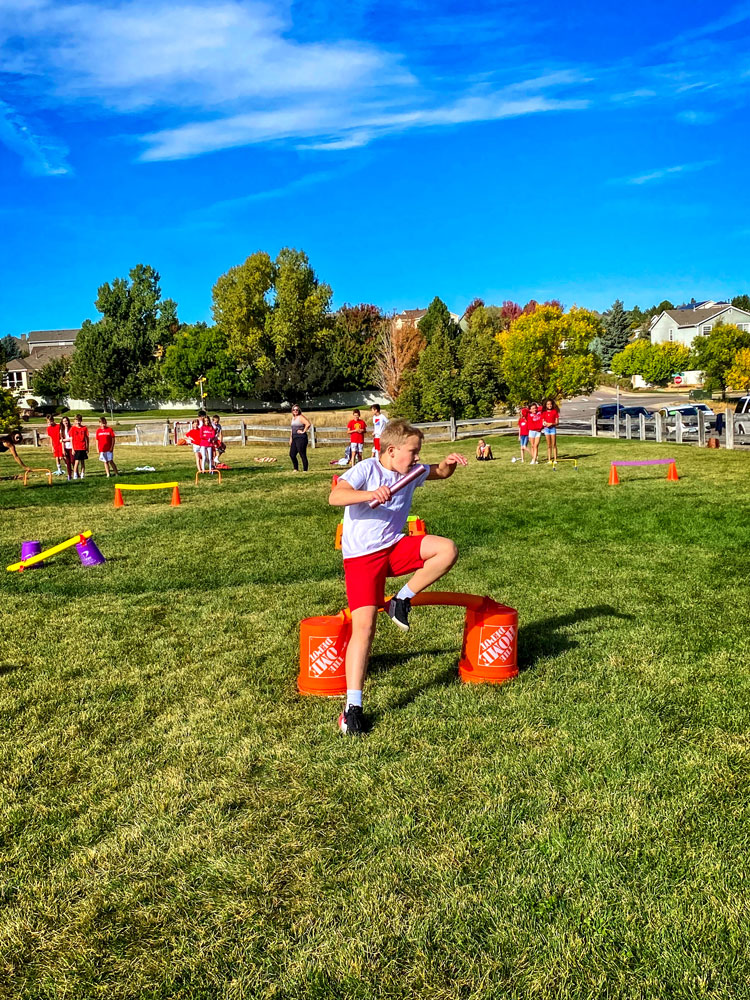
[{"left": 161, "top": 323, "right": 239, "bottom": 399}]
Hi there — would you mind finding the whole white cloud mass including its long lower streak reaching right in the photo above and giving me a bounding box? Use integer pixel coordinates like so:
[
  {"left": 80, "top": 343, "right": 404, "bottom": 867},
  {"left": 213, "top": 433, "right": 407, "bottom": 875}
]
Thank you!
[{"left": 0, "top": 0, "right": 588, "bottom": 160}]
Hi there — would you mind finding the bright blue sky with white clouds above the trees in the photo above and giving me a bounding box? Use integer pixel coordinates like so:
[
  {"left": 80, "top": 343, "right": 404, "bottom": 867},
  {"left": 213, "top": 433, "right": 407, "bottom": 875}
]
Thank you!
[{"left": 0, "top": 0, "right": 750, "bottom": 336}]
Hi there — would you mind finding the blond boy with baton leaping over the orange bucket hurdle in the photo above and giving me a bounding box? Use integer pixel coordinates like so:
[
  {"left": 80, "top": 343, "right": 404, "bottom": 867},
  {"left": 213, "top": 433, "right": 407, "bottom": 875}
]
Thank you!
[{"left": 328, "top": 420, "right": 467, "bottom": 736}]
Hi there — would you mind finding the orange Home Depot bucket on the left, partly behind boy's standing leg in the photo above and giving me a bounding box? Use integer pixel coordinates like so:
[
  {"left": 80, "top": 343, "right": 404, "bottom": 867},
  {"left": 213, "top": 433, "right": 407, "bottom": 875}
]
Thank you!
[{"left": 297, "top": 611, "right": 352, "bottom": 698}]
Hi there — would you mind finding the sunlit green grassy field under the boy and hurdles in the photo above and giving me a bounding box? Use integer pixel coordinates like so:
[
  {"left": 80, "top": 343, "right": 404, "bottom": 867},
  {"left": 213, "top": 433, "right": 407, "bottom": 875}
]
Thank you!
[{"left": 0, "top": 439, "right": 750, "bottom": 1000}]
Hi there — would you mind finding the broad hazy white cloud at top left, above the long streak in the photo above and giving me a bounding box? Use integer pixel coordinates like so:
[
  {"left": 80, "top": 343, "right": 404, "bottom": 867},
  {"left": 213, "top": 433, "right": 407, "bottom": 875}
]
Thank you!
[{"left": 0, "top": 0, "right": 412, "bottom": 111}]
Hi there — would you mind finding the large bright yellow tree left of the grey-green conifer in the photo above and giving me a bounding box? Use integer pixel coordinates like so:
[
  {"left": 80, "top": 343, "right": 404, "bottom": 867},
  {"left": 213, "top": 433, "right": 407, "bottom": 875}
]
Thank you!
[{"left": 498, "top": 306, "right": 602, "bottom": 405}]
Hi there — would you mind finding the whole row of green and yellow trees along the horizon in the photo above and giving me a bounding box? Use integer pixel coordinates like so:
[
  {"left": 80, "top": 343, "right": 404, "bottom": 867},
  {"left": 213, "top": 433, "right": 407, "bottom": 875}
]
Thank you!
[{"left": 17, "top": 254, "right": 750, "bottom": 420}]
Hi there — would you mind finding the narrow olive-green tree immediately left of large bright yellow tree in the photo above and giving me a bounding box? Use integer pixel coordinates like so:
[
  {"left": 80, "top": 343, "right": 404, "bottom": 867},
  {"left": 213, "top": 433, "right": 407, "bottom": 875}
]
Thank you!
[{"left": 457, "top": 305, "right": 507, "bottom": 419}]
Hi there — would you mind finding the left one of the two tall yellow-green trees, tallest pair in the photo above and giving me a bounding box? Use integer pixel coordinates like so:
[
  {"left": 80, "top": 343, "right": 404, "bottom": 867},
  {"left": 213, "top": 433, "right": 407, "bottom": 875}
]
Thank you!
[{"left": 212, "top": 250, "right": 276, "bottom": 372}]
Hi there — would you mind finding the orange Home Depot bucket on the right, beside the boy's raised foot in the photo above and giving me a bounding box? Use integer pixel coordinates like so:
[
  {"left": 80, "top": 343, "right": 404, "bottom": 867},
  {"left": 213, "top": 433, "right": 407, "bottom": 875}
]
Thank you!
[{"left": 458, "top": 600, "right": 518, "bottom": 684}]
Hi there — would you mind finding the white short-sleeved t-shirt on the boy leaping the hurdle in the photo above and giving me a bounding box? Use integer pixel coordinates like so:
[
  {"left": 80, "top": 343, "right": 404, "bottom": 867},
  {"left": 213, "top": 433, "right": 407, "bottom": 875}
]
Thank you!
[{"left": 340, "top": 458, "right": 429, "bottom": 559}]
